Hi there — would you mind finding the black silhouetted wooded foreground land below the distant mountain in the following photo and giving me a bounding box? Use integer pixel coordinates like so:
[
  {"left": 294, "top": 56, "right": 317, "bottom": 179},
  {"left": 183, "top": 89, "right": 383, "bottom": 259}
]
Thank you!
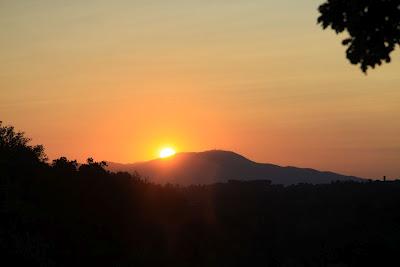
[{"left": 0, "top": 124, "right": 400, "bottom": 266}]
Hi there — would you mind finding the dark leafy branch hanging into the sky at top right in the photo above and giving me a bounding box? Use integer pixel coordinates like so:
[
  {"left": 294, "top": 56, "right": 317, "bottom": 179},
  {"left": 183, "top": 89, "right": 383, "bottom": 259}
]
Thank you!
[{"left": 318, "top": 0, "right": 400, "bottom": 73}]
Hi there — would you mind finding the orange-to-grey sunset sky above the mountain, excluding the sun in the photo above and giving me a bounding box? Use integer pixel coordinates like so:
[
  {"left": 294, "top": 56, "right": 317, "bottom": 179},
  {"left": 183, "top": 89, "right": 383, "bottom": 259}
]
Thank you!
[{"left": 0, "top": 0, "right": 400, "bottom": 178}]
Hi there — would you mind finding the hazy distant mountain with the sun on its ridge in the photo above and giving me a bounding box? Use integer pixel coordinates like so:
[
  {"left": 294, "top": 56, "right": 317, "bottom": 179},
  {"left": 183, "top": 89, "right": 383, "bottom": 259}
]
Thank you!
[{"left": 108, "top": 150, "right": 361, "bottom": 185}]
